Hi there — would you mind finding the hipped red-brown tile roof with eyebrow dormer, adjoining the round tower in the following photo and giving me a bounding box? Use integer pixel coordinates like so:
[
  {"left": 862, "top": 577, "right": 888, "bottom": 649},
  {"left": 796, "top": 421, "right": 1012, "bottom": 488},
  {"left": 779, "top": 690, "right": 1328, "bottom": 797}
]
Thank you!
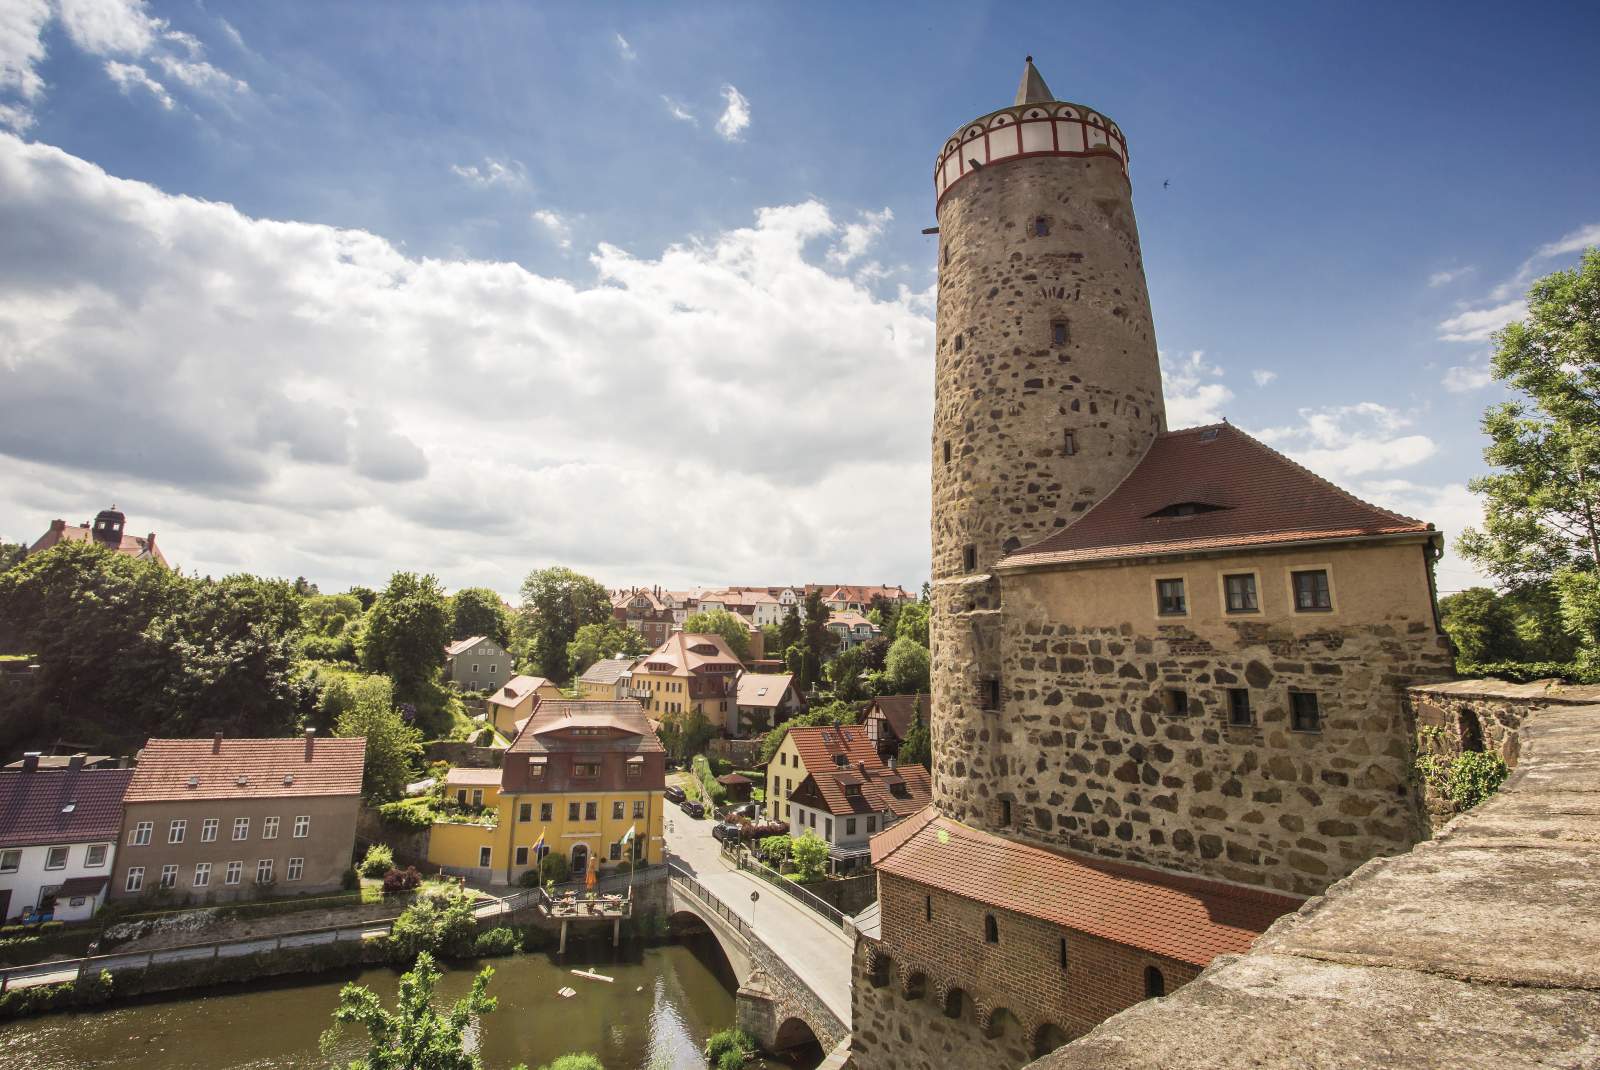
[{"left": 997, "top": 424, "right": 1430, "bottom": 568}]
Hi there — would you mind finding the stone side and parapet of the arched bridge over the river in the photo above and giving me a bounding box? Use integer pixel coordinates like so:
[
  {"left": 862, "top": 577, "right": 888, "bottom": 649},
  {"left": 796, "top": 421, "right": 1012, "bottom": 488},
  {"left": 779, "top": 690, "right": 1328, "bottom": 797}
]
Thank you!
[{"left": 669, "top": 864, "right": 850, "bottom": 1067}]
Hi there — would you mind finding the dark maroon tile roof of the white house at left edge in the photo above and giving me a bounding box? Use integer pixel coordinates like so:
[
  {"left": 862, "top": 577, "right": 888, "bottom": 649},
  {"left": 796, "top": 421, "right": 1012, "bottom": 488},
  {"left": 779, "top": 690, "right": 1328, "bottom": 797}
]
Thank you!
[{"left": 0, "top": 769, "right": 133, "bottom": 848}]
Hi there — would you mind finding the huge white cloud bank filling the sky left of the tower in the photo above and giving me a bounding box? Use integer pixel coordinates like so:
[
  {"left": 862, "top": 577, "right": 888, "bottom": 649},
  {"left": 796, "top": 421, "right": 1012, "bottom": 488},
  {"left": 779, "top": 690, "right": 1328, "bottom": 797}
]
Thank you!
[{"left": 0, "top": 134, "right": 933, "bottom": 595}]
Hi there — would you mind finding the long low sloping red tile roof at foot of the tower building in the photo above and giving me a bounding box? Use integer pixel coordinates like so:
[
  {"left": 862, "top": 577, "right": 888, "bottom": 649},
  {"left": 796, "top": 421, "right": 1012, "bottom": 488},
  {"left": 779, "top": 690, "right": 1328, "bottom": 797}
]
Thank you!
[{"left": 872, "top": 806, "right": 1304, "bottom": 966}]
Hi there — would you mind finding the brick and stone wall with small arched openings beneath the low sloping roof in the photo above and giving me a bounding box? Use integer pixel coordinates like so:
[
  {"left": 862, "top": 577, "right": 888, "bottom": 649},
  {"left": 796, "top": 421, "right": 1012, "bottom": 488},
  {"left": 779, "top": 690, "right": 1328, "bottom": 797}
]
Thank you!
[{"left": 851, "top": 873, "right": 1198, "bottom": 1070}]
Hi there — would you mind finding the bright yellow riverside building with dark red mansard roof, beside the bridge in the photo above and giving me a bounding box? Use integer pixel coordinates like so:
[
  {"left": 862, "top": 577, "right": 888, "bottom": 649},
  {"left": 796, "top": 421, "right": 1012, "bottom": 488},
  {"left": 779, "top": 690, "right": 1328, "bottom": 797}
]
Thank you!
[{"left": 427, "top": 699, "right": 666, "bottom": 884}]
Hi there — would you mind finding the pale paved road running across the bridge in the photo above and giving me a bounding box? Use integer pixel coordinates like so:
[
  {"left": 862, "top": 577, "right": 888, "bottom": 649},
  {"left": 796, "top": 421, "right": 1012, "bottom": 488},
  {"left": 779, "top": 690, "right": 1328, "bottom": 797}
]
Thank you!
[{"left": 666, "top": 806, "right": 853, "bottom": 1027}]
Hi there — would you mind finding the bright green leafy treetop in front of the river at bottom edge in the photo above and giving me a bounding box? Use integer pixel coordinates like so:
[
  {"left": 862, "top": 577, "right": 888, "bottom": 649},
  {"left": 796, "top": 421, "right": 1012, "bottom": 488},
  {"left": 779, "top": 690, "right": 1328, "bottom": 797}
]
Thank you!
[{"left": 322, "top": 952, "right": 498, "bottom": 1070}]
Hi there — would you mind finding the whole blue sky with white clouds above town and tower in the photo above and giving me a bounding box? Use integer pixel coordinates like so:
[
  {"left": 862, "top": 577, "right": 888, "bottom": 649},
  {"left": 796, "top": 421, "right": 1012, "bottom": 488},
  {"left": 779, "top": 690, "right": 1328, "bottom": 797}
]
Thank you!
[{"left": 0, "top": 0, "right": 1600, "bottom": 598}]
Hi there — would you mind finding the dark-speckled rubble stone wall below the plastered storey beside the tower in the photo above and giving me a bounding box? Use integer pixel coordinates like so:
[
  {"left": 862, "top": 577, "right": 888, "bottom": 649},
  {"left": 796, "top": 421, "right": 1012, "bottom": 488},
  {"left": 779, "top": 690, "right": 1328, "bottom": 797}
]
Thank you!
[{"left": 934, "top": 574, "right": 1450, "bottom": 894}]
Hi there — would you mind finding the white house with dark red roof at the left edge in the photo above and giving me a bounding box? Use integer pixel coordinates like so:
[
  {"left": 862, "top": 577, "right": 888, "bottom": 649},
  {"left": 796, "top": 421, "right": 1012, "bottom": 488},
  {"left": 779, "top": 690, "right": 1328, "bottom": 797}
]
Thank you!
[{"left": 0, "top": 753, "right": 133, "bottom": 921}]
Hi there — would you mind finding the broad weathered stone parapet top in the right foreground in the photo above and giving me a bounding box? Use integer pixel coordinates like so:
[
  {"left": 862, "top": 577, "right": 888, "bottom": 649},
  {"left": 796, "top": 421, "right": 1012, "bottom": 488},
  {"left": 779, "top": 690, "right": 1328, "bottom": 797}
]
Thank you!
[{"left": 1030, "top": 681, "right": 1600, "bottom": 1070}]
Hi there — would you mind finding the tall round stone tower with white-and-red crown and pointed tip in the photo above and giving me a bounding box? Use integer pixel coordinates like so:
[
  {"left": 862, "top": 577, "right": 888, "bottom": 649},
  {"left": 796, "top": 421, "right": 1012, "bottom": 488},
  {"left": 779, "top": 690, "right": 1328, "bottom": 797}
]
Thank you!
[{"left": 931, "top": 56, "right": 1165, "bottom": 828}]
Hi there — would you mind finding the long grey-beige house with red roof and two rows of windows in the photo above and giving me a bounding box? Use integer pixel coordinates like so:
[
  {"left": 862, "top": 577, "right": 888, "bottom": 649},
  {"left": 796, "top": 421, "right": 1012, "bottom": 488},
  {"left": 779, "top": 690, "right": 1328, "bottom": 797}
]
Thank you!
[{"left": 110, "top": 731, "right": 366, "bottom": 902}]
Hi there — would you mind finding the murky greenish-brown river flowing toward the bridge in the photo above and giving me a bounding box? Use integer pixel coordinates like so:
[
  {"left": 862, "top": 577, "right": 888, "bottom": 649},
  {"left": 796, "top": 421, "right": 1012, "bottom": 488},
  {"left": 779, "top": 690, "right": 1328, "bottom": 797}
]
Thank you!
[{"left": 0, "top": 937, "right": 816, "bottom": 1070}]
